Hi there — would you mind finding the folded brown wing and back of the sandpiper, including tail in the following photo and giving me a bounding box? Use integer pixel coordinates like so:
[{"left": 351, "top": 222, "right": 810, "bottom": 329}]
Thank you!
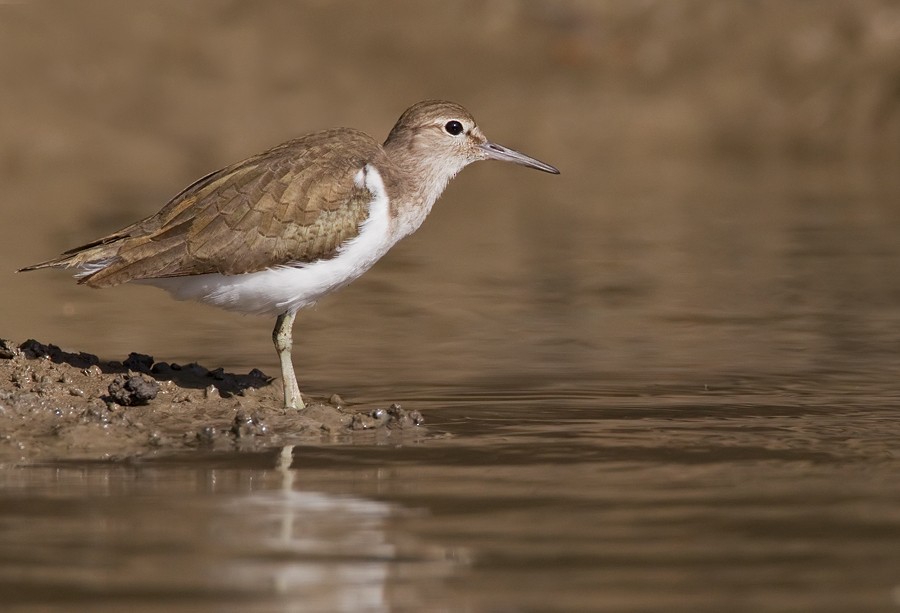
[{"left": 26, "top": 129, "right": 384, "bottom": 287}]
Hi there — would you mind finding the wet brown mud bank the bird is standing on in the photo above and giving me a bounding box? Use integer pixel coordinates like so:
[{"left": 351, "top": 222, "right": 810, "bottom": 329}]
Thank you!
[{"left": 0, "top": 340, "right": 424, "bottom": 465}]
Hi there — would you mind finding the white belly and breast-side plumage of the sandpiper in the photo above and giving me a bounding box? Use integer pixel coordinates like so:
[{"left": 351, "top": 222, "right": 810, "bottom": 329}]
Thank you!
[{"left": 140, "top": 164, "right": 400, "bottom": 315}]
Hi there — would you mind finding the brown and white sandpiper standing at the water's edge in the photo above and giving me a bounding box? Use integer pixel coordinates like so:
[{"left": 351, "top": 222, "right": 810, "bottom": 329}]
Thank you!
[{"left": 21, "top": 100, "right": 559, "bottom": 409}]
